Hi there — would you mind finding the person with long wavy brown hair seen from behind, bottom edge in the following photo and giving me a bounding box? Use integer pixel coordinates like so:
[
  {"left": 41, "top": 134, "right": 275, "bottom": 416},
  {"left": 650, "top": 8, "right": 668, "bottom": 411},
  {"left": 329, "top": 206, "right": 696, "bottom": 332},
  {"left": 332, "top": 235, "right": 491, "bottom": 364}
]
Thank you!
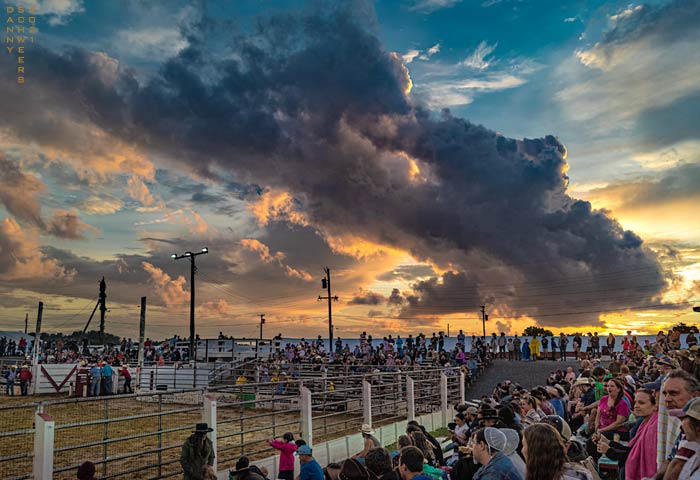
[{"left": 523, "top": 423, "right": 592, "bottom": 480}]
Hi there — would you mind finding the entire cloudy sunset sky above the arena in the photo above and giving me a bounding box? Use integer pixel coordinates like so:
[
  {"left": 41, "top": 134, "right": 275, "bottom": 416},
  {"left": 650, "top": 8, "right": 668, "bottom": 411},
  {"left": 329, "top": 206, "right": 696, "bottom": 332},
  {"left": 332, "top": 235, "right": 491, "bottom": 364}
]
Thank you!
[{"left": 0, "top": 0, "right": 700, "bottom": 338}]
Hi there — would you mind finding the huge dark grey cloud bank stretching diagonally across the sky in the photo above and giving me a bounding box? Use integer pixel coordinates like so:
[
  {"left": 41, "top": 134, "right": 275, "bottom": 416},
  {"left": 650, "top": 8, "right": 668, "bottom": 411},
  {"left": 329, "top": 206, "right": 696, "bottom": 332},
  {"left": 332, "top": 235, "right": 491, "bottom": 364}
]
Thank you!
[{"left": 0, "top": 2, "right": 664, "bottom": 323}]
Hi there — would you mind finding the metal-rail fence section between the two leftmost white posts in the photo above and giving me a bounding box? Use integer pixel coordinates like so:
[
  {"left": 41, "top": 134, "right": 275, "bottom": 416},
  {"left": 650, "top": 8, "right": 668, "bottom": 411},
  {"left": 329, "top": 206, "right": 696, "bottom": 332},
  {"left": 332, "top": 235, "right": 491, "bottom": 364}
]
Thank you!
[{"left": 41, "top": 390, "right": 202, "bottom": 479}]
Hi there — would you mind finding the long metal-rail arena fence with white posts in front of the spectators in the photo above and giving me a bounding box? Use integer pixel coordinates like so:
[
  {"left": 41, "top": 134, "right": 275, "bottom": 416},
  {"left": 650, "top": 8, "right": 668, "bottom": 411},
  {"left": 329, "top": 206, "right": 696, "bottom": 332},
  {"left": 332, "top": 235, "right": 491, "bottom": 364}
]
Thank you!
[{"left": 0, "top": 368, "right": 478, "bottom": 480}]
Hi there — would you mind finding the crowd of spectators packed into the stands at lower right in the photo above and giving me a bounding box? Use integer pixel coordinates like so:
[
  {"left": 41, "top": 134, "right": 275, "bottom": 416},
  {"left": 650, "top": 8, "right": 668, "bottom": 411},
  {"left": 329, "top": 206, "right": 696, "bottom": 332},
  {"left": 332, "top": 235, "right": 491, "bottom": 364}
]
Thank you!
[{"left": 202, "top": 334, "right": 700, "bottom": 480}]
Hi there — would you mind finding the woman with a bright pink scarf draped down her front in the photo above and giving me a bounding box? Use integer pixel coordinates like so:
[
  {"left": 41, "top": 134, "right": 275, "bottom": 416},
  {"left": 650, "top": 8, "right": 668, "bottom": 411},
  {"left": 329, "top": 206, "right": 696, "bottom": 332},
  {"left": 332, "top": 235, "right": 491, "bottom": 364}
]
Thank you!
[{"left": 598, "top": 388, "right": 659, "bottom": 480}]
